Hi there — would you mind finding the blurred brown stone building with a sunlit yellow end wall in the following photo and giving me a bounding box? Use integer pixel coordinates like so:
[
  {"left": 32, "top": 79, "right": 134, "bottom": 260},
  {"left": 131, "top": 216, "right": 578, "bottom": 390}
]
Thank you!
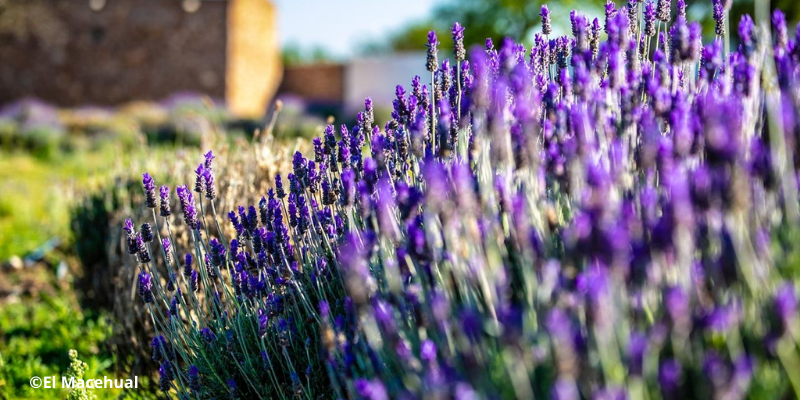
[{"left": 0, "top": 0, "right": 282, "bottom": 117}]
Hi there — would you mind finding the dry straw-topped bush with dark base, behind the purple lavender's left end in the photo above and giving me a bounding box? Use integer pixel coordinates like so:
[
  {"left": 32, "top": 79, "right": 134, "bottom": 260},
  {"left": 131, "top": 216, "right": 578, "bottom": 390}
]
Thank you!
[{"left": 71, "top": 132, "right": 296, "bottom": 376}]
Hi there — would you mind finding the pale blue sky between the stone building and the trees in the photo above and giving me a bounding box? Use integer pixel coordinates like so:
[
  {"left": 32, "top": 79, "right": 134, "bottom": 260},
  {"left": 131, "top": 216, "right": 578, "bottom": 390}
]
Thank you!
[{"left": 274, "top": 0, "right": 442, "bottom": 58}]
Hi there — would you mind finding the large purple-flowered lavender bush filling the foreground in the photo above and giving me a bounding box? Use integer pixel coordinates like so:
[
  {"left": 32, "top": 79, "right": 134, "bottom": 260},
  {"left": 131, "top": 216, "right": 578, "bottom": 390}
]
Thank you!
[{"left": 126, "top": 0, "right": 800, "bottom": 400}]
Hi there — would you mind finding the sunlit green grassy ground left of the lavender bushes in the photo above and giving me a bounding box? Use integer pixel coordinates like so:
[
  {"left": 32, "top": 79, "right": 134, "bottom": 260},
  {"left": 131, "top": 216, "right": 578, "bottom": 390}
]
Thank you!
[{"left": 0, "top": 146, "right": 147, "bottom": 400}]
